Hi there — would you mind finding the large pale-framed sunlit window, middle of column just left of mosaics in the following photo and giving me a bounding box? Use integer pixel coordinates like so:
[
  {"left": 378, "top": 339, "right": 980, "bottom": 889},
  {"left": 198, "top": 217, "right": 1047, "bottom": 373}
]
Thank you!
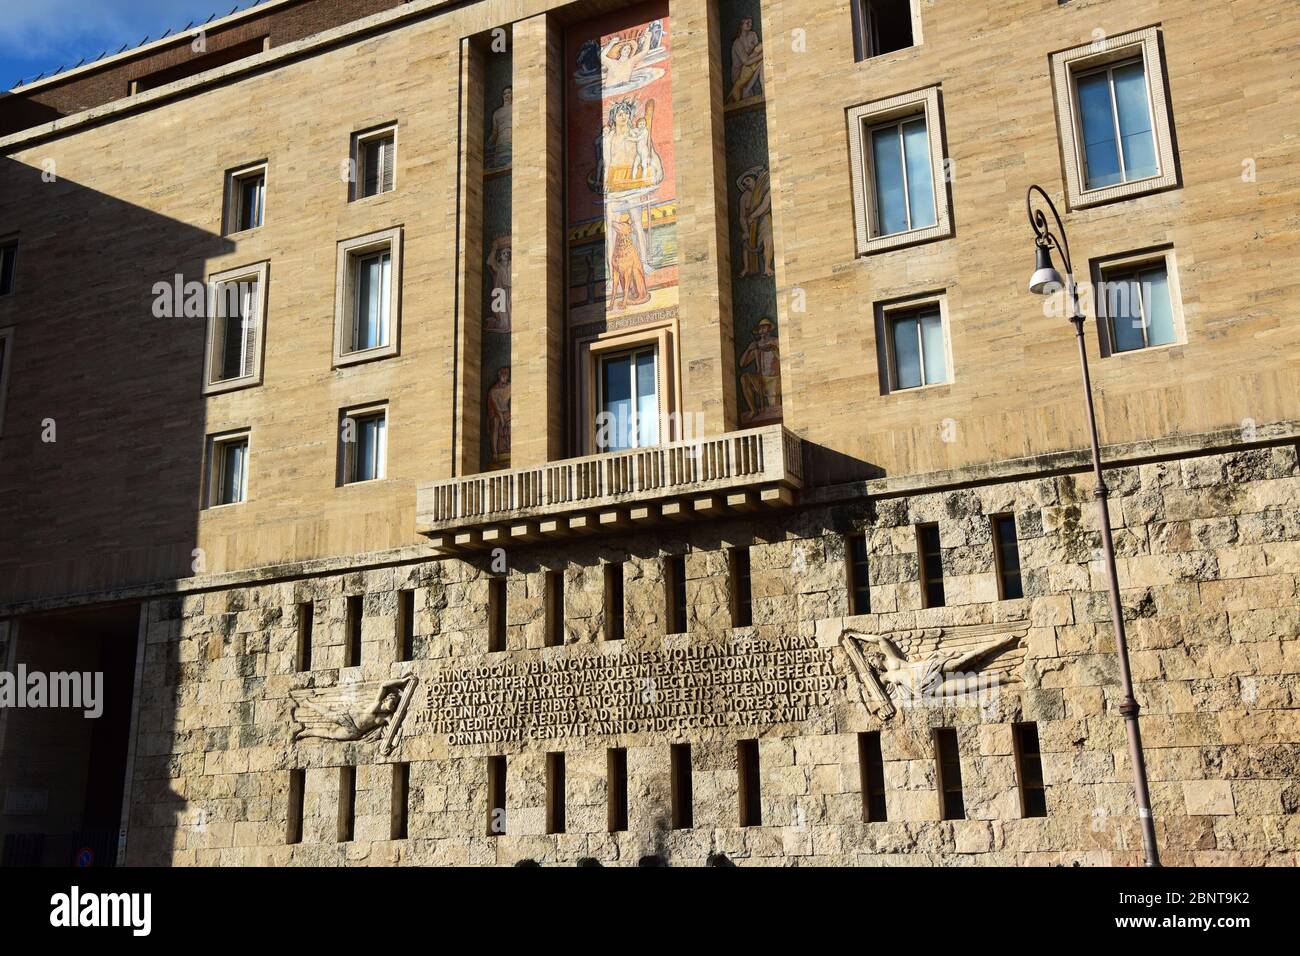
[{"left": 334, "top": 226, "right": 402, "bottom": 365}]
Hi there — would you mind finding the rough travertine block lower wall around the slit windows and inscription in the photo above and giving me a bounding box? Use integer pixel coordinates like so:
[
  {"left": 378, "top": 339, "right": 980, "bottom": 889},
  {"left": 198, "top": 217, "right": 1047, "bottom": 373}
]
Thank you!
[{"left": 127, "top": 445, "right": 1300, "bottom": 865}]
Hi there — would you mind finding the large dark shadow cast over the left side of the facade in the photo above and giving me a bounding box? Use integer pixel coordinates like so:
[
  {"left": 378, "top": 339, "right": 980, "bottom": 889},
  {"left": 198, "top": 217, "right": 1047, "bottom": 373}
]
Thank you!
[{"left": 0, "top": 155, "right": 233, "bottom": 865}]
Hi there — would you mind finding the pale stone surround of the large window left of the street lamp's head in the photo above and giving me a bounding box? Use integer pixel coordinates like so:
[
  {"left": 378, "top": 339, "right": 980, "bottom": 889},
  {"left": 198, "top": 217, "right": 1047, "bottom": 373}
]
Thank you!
[{"left": 848, "top": 86, "right": 953, "bottom": 256}]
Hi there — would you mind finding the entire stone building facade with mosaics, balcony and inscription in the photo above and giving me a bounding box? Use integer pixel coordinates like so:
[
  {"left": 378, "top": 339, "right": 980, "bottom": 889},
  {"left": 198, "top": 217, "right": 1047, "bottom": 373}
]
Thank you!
[{"left": 0, "top": 0, "right": 1300, "bottom": 865}]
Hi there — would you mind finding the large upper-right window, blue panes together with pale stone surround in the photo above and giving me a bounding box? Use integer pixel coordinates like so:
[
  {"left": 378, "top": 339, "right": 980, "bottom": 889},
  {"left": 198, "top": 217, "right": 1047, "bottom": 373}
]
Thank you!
[{"left": 1052, "top": 27, "right": 1178, "bottom": 209}]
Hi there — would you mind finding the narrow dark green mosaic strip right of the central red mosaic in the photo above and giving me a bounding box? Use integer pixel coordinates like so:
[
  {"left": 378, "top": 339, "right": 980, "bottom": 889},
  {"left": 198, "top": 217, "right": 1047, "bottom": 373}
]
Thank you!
[{"left": 718, "top": 0, "right": 781, "bottom": 428}]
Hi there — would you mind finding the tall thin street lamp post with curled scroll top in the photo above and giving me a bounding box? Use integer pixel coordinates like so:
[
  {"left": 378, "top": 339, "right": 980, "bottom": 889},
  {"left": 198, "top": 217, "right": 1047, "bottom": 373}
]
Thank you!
[{"left": 1024, "top": 186, "right": 1160, "bottom": 866}]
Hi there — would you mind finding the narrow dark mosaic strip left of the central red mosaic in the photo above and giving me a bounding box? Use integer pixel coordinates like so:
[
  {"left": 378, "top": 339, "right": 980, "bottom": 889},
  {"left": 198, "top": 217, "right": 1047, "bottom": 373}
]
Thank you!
[{"left": 480, "top": 27, "right": 515, "bottom": 471}]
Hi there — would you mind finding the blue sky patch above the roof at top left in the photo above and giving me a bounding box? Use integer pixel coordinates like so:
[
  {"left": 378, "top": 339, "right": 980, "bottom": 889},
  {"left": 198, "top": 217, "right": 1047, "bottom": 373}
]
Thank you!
[{"left": 0, "top": 0, "right": 265, "bottom": 90}]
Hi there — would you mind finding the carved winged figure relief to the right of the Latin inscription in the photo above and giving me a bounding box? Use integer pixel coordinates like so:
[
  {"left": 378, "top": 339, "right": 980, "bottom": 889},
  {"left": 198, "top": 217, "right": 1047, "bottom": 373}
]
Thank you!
[{"left": 840, "top": 622, "right": 1028, "bottom": 721}]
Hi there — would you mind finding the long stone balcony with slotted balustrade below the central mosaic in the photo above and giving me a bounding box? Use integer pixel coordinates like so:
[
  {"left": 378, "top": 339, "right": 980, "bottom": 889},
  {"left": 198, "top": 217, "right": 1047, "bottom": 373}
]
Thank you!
[{"left": 416, "top": 425, "right": 803, "bottom": 553}]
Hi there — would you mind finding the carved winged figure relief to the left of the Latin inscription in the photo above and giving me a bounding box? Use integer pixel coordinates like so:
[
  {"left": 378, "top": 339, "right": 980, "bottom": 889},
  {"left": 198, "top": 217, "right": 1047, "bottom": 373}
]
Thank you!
[{"left": 289, "top": 674, "right": 420, "bottom": 754}]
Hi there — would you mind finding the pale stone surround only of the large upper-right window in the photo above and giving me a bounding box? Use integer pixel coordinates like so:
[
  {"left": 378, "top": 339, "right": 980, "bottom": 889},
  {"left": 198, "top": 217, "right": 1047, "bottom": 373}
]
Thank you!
[{"left": 1052, "top": 26, "right": 1178, "bottom": 209}]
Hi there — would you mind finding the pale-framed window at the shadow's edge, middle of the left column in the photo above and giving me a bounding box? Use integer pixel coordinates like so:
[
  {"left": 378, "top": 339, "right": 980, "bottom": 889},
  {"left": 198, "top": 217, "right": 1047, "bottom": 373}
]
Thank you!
[{"left": 204, "top": 263, "right": 269, "bottom": 394}]
